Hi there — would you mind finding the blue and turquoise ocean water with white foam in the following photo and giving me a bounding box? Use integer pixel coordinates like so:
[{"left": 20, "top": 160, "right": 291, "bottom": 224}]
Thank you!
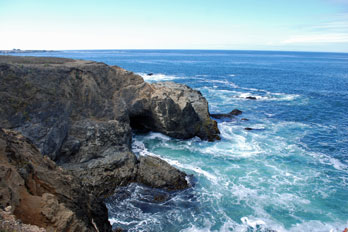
[{"left": 9, "top": 50, "right": 348, "bottom": 231}]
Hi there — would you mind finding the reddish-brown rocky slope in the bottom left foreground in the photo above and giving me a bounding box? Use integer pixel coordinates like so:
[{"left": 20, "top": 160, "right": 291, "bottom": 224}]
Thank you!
[{"left": 0, "top": 129, "right": 111, "bottom": 231}]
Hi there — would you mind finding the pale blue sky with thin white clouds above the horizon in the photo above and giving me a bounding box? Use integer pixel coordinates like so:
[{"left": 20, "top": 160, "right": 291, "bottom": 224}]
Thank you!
[{"left": 0, "top": 0, "right": 348, "bottom": 52}]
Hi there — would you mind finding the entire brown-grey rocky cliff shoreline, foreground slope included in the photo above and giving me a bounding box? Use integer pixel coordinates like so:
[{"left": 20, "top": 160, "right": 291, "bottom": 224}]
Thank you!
[{"left": 0, "top": 56, "right": 220, "bottom": 231}]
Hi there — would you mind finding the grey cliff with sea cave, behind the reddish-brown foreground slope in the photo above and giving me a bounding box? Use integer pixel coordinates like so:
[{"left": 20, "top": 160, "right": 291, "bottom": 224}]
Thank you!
[{"left": 0, "top": 56, "right": 220, "bottom": 196}]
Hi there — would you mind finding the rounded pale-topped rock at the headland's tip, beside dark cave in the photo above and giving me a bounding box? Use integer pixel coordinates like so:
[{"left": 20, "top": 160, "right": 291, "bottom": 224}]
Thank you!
[{"left": 132, "top": 82, "right": 220, "bottom": 141}]
